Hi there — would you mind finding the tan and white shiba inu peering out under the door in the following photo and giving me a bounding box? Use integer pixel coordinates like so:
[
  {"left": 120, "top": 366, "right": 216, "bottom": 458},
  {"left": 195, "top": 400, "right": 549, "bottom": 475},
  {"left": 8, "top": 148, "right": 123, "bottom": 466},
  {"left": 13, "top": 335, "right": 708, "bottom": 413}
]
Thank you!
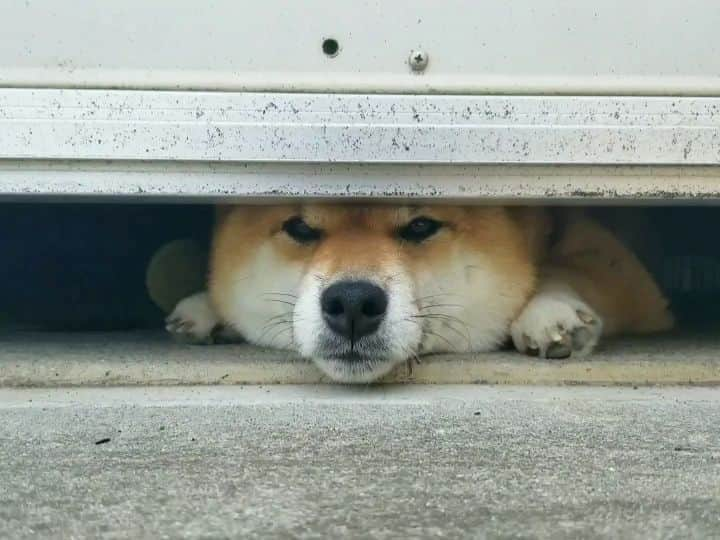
[{"left": 167, "top": 204, "right": 673, "bottom": 382}]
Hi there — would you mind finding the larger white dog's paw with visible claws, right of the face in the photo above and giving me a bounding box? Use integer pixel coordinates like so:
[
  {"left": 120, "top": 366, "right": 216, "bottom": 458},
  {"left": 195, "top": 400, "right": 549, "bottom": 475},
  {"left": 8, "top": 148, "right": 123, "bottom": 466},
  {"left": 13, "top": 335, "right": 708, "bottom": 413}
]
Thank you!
[{"left": 510, "top": 291, "right": 602, "bottom": 358}]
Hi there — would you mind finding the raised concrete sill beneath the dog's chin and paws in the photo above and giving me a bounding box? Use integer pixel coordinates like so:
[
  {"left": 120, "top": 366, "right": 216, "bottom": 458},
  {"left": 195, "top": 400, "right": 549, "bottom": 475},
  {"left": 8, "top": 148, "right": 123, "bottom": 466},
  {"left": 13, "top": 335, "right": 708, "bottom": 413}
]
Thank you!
[{"left": 0, "top": 326, "right": 720, "bottom": 388}]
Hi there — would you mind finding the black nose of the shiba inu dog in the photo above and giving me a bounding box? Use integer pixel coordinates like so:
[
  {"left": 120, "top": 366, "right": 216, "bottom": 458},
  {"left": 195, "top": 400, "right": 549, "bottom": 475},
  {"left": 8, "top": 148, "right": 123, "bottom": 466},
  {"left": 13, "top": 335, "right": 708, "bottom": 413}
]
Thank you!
[{"left": 320, "top": 281, "right": 387, "bottom": 342}]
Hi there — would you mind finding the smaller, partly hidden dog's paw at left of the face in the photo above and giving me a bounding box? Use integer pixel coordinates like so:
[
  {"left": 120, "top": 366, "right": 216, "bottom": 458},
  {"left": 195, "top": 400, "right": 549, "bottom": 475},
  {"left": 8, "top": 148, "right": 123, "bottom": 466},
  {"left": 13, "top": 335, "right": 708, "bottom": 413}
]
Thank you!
[{"left": 165, "top": 292, "right": 220, "bottom": 344}]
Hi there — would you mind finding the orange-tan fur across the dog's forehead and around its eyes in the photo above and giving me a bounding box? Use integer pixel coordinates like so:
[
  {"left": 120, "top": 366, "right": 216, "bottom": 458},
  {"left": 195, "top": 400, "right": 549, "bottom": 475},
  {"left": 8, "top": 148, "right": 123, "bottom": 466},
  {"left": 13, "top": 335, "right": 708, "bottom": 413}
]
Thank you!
[{"left": 209, "top": 205, "right": 550, "bottom": 332}]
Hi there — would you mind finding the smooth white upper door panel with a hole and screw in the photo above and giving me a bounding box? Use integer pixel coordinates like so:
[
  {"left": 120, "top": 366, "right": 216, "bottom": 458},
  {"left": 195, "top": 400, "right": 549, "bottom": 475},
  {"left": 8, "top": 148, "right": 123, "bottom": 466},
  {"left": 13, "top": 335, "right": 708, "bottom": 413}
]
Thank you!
[{"left": 0, "top": 0, "right": 720, "bottom": 95}]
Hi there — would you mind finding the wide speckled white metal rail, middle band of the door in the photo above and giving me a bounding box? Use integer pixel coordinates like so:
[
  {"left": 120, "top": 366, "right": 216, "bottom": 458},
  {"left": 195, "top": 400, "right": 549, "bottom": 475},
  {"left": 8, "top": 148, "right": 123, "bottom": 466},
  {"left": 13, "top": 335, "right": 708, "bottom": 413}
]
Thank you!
[{"left": 0, "top": 89, "right": 720, "bottom": 165}]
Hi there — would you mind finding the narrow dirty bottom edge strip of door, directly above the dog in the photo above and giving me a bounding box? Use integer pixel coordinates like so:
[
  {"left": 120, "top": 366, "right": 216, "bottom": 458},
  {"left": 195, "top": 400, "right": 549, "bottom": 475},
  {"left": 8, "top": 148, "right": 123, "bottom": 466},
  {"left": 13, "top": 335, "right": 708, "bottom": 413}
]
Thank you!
[{"left": 0, "top": 160, "right": 720, "bottom": 204}]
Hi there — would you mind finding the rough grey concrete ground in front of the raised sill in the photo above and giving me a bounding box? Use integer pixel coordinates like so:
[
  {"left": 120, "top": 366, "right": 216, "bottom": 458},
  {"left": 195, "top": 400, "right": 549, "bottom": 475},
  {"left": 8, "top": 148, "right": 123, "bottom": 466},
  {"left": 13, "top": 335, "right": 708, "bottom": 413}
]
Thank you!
[{"left": 0, "top": 385, "right": 720, "bottom": 539}]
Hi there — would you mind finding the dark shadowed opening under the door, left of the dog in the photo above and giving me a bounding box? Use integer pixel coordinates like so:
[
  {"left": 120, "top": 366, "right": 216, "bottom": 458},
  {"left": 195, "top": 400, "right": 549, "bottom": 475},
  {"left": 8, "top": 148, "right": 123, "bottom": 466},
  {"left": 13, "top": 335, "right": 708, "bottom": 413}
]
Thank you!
[{"left": 0, "top": 204, "right": 213, "bottom": 331}]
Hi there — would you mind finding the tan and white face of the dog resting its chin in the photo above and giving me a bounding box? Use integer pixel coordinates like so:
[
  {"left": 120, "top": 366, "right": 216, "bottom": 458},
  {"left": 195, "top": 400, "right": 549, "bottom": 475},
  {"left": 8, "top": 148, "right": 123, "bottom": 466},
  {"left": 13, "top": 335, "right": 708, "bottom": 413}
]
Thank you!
[{"left": 210, "top": 204, "right": 534, "bottom": 382}]
